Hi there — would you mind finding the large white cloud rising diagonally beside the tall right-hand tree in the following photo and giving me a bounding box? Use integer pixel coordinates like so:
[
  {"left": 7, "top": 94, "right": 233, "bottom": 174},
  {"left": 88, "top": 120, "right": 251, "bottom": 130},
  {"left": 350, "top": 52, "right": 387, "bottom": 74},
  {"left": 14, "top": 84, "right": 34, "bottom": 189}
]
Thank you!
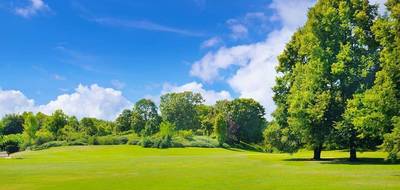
[{"left": 190, "top": 0, "right": 314, "bottom": 117}]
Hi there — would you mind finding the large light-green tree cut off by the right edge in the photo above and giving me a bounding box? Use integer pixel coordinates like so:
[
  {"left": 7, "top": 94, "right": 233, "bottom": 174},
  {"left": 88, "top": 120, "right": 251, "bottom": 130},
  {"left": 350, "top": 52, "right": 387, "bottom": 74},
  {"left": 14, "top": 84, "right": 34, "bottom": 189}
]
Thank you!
[{"left": 340, "top": 0, "right": 400, "bottom": 160}]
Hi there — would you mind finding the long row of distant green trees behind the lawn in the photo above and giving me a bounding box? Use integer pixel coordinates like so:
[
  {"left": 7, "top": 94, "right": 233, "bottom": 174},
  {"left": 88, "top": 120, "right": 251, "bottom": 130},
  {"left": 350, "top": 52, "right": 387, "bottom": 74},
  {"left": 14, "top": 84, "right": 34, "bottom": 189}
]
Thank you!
[{"left": 0, "top": 92, "right": 266, "bottom": 154}]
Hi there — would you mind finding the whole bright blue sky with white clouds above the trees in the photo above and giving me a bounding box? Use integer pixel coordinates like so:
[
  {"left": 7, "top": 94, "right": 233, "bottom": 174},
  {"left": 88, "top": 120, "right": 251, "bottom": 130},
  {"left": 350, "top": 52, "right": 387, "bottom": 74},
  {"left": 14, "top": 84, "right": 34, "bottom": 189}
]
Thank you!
[{"left": 0, "top": 0, "right": 386, "bottom": 119}]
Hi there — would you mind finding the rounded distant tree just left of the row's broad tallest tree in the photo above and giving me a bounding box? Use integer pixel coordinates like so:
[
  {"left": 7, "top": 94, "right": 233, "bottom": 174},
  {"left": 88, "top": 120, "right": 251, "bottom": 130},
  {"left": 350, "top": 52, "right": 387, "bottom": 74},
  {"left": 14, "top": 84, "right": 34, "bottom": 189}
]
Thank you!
[{"left": 131, "top": 99, "right": 161, "bottom": 135}]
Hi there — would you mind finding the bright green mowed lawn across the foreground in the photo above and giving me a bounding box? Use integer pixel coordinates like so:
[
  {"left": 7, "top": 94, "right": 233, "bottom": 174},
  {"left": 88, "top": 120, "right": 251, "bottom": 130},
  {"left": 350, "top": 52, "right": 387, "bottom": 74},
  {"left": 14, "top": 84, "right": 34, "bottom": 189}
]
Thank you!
[{"left": 0, "top": 146, "right": 400, "bottom": 190}]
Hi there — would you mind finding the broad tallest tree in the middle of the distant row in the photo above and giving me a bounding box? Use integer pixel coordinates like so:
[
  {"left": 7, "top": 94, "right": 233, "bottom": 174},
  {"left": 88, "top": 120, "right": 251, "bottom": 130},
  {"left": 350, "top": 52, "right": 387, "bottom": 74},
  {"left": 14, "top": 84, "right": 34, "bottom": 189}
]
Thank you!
[{"left": 160, "top": 92, "right": 204, "bottom": 130}]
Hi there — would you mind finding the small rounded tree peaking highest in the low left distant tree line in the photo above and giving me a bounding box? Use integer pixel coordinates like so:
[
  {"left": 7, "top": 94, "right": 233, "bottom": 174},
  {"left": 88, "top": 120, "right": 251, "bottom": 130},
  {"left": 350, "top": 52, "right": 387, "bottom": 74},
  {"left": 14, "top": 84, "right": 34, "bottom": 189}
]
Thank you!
[{"left": 46, "top": 110, "right": 68, "bottom": 138}]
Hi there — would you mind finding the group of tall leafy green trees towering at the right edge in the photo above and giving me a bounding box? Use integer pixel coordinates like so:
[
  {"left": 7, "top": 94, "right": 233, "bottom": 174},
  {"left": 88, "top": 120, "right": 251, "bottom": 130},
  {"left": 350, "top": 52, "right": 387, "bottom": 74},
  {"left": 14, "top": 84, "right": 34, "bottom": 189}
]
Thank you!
[{"left": 265, "top": 0, "right": 400, "bottom": 160}]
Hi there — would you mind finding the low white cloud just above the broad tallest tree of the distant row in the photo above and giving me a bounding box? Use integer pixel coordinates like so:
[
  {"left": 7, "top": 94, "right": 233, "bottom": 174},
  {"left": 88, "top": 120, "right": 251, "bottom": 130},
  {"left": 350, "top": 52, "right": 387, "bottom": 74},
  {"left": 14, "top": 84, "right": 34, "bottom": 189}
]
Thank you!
[{"left": 161, "top": 82, "right": 232, "bottom": 105}]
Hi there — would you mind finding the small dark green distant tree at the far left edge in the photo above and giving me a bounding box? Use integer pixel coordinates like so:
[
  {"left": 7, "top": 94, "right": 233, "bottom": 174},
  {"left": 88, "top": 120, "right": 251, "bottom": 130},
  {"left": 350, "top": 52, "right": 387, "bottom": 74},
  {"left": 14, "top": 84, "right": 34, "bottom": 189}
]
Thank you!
[{"left": 0, "top": 114, "right": 24, "bottom": 135}]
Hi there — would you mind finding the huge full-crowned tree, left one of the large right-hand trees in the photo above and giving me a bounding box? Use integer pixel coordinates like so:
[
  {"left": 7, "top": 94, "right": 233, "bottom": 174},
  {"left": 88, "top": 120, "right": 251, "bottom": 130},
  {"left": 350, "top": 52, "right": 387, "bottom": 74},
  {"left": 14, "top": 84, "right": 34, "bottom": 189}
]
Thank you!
[{"left": 269, "top": 0, "right": 378, "bottom": 159}]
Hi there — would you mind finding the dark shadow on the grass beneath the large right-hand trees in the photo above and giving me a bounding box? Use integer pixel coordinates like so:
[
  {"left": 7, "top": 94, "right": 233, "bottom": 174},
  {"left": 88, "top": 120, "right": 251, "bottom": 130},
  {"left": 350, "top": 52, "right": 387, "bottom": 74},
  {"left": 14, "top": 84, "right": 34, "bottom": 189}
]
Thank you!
[{"left": 284, "top": 158, "right": 400, "bottom": 165}]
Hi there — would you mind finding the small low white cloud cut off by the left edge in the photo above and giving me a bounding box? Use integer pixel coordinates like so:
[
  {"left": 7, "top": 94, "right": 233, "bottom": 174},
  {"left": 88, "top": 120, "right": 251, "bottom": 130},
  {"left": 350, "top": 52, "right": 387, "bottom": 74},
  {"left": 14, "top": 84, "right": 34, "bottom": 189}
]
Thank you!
[{"left": 0, "top": 90, "right": 35, "bottom": 117}]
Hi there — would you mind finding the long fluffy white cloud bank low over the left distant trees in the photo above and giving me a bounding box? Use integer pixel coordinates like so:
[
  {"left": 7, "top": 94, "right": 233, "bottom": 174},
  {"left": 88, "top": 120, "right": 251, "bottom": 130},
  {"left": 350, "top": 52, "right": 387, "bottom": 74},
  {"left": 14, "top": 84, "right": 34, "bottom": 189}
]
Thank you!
[{"left": 0, "top": 84, "right": 132, "bottom": 120}]
